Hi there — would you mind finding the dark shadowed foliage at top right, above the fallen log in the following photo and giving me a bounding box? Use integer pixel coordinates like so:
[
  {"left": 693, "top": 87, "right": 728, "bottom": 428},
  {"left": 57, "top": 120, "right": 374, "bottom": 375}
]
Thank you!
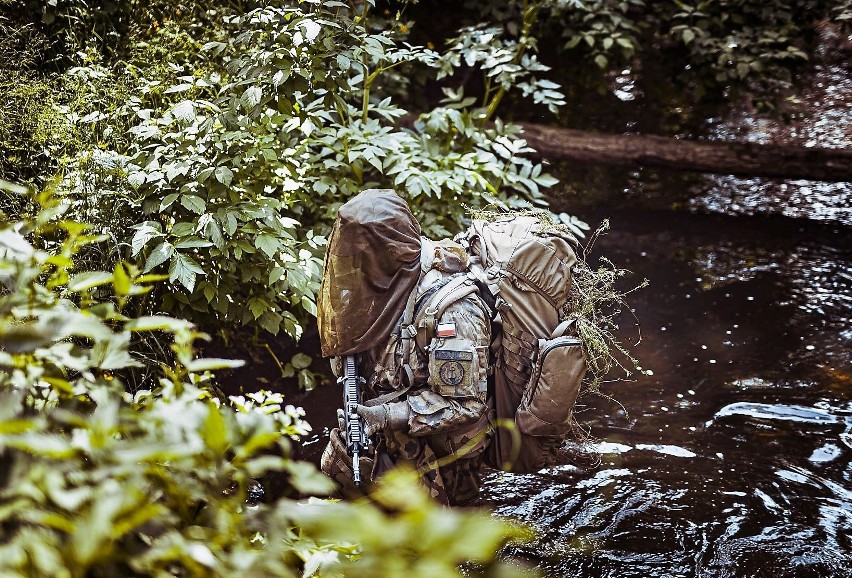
[{"left": 450, "top": 0, "right": 852, "bottom": 117}]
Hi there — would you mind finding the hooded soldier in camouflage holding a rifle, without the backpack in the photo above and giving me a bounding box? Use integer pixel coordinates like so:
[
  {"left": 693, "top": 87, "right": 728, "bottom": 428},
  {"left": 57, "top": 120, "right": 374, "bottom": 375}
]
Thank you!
[{"left": 318, "top": 189, "right": 493, "bottom": 505}]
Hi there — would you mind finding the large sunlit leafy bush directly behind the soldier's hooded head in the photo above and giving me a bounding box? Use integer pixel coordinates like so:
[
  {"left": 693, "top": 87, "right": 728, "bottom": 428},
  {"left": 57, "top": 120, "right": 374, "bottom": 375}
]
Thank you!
[{"left": 115, "top": 2, "right": 555, "bottom": 338}]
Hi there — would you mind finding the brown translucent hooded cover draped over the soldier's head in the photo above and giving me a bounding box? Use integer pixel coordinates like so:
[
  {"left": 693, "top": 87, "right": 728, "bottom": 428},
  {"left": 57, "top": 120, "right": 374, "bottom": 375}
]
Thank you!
[{"left": 317, "top": 189, "right": 420, "bottom": 357}]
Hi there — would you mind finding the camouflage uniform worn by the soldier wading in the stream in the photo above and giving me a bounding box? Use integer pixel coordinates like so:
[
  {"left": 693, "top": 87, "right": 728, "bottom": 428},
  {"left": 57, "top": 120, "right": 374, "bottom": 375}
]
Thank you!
[{"left": 322, "top": 270, "right": 492, "bottom": 505}]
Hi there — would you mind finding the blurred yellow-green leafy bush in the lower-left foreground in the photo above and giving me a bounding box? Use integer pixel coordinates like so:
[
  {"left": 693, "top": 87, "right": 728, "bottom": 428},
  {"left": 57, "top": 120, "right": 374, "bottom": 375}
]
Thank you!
[{"left": 0, "top": 184, "right": 522, "bottom": 577}]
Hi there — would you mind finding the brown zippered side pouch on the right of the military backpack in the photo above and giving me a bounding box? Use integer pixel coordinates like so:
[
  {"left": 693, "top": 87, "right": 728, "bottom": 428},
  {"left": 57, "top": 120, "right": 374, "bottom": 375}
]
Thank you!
[{"left": 515, "top": 336, "right": 586, "bottom": 436}]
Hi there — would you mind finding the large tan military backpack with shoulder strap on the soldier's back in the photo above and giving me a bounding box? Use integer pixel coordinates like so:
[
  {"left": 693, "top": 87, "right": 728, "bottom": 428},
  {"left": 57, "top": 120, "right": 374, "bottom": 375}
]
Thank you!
[{"left": 414, "top": 215, "right": 586, "bottom": 473}]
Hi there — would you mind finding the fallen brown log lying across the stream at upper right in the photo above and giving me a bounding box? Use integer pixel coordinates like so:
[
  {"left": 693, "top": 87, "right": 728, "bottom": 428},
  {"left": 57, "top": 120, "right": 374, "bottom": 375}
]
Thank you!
[{"left": 521, "top": 123, "right": 852, "bottom": 182}]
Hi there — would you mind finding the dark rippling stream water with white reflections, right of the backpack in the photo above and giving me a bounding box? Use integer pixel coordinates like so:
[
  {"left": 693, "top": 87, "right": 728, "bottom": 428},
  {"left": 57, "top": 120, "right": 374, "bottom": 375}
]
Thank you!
[{"left": 483, "top": 51, "right": 852, "bottom": 578}]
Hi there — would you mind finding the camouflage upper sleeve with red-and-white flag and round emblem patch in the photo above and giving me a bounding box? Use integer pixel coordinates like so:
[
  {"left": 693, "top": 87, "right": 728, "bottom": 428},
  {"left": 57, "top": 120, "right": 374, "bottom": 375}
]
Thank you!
[{"left": 408, "top": 296, "right": 491, "bottom": 435}]
